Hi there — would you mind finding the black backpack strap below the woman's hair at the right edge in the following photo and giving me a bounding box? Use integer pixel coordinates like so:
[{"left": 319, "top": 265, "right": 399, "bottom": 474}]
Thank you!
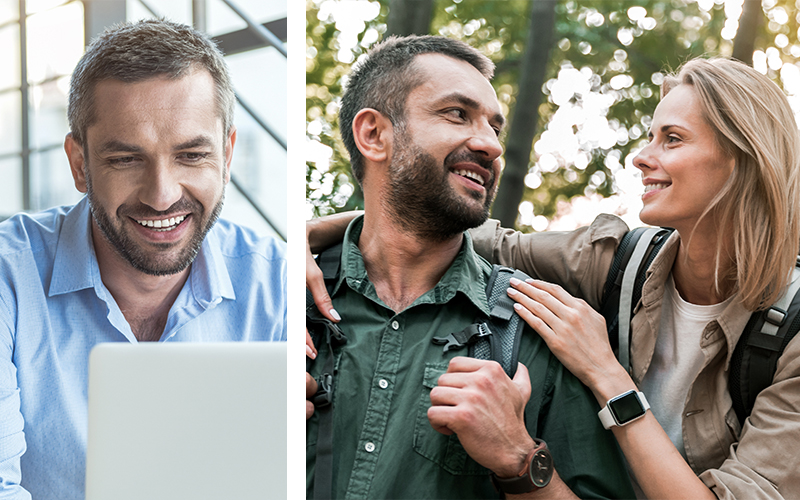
[{"left": 728, "top": 257, "right": 800, "bottom": 425}]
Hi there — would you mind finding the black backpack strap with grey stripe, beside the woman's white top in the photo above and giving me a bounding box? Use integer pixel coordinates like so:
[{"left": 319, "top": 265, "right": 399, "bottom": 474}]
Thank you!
[{"left": 600, "top": 227, "right": 674, "bottom": 370}]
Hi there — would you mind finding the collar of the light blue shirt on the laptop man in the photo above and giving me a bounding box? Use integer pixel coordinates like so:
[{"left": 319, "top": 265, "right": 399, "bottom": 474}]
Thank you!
[{"left": 49, "top": 197, "right": 236, "bottom": 307}]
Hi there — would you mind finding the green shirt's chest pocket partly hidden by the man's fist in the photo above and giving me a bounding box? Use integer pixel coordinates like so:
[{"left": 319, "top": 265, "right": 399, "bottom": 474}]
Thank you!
[{"left": 414, "top": 363, "right": 489, "bottom": 476}]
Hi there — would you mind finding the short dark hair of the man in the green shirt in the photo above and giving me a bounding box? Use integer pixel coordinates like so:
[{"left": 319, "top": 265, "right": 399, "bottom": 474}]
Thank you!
[{"left": 339, "top": 35, "right": 494, "bottom": 183}]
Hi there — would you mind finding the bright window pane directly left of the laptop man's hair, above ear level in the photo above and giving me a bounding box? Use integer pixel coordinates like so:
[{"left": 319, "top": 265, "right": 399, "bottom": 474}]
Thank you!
[{"left": 29, "top": 77, "right": 69, "bottom": 149}]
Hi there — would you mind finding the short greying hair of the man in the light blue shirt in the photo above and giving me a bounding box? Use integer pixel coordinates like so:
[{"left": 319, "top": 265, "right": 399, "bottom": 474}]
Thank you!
[{"left": 67, "top": 19, "right": 236, "bottom": 146}]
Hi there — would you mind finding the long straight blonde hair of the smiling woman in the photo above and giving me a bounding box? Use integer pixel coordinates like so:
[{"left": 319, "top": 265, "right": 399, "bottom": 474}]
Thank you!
[{"left": 661, "top": 58, "right": 800, "bottom": 311}]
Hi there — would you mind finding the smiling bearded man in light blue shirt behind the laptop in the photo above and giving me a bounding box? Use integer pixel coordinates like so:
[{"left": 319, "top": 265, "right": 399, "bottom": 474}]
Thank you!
[{"left": 0, "top": 20, "right": 286, "bottom": 500}]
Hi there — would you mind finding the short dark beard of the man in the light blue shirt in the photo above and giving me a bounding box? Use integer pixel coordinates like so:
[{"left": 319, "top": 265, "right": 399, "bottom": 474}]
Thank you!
[{"left": 86, "top": 172, "right": 225, "bottom": 276}]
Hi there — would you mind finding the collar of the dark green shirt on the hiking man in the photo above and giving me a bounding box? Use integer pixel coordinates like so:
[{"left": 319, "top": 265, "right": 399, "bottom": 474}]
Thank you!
[{"left": 333, "top": 216, "right": 491, "bottom": 316}]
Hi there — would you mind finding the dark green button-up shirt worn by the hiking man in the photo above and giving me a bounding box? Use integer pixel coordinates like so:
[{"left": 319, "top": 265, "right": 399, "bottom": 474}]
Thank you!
[{"left": 306, "top": 219, "right": 634, "bottom": 499}]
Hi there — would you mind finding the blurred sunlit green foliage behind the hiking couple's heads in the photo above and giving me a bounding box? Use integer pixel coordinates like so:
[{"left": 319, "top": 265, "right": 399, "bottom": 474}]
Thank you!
[{"left": 306, "top": 0, "right": 800, "bottom": 230}]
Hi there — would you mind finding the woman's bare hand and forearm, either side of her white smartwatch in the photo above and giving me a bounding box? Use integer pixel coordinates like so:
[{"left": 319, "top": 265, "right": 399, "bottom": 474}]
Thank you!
[{"left": 509, "top": 280, "right": 717, "bottom": 500}]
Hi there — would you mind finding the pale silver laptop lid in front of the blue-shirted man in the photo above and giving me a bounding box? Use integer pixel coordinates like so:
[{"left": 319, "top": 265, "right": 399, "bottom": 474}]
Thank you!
[{"left": 86, "top": 342, "right": 286, "bottom": 500}]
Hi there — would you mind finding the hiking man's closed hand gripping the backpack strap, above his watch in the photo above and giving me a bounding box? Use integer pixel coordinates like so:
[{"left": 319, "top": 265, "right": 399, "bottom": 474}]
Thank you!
[{"left": 428, "top": 357, "right": 535, "bottom": 477}]
